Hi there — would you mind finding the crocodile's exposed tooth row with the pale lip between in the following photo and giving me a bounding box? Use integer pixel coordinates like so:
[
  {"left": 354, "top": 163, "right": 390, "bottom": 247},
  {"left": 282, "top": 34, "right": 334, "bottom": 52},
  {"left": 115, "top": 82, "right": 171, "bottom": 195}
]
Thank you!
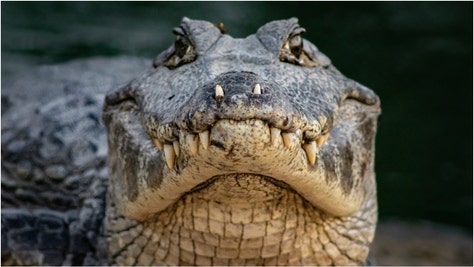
[{"left": 152, "top": 119, "right": 329, "bottom": 170}]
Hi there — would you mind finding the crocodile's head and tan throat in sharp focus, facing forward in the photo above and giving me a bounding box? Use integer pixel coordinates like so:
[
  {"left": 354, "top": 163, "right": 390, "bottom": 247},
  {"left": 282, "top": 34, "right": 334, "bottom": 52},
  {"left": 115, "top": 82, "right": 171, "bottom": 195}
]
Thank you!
[{"left": 104, "top": 18, "right": 380, "bottom": 265}]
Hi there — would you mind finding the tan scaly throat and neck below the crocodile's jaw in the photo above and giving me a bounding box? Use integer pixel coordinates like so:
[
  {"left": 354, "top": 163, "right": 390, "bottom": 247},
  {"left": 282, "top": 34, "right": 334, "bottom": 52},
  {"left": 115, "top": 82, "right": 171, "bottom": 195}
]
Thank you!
[{"left": 105, "top": 174, "right": 377, "bottom": 265}]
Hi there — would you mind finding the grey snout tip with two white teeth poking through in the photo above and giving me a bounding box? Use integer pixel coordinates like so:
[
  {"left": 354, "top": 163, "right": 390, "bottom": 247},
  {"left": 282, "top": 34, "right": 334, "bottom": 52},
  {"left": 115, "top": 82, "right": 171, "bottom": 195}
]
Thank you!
[{"left": 175, "top": 72, "right": 299, "bottom": 132}]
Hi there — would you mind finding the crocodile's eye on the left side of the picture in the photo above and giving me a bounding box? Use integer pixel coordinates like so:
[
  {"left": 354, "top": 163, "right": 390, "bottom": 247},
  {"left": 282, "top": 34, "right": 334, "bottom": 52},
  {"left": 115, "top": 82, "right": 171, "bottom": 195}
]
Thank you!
[{"left": 164, "top": 28, "right": 197, "bottom": 69}]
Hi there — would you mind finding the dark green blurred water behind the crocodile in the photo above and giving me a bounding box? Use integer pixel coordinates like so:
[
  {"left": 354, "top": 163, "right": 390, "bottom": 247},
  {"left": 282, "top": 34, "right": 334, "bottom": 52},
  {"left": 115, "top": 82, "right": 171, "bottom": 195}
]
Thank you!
[{"left": 1, "top": 2, "right": 473, "bottom": 229}]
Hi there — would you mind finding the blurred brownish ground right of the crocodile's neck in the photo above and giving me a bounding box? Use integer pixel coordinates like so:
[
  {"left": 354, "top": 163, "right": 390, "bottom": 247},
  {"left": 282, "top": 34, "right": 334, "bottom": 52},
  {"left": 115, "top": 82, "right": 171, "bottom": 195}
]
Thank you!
[{"left": 372, "top": 220, "right": 473, "bottom": 266}]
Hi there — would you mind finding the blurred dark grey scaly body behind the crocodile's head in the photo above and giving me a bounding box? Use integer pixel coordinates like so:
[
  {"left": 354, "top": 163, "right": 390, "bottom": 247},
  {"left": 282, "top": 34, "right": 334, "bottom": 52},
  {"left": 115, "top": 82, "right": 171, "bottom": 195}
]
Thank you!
[{"left": 1, "top": 57, "right": 149, "bottom": 266}]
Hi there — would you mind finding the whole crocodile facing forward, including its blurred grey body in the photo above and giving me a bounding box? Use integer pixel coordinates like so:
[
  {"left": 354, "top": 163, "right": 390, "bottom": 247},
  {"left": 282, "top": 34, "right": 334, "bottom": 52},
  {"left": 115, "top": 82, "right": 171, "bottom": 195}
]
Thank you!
[{"left": 2, "top": 17, "right": 381, "bottom": 265}]
